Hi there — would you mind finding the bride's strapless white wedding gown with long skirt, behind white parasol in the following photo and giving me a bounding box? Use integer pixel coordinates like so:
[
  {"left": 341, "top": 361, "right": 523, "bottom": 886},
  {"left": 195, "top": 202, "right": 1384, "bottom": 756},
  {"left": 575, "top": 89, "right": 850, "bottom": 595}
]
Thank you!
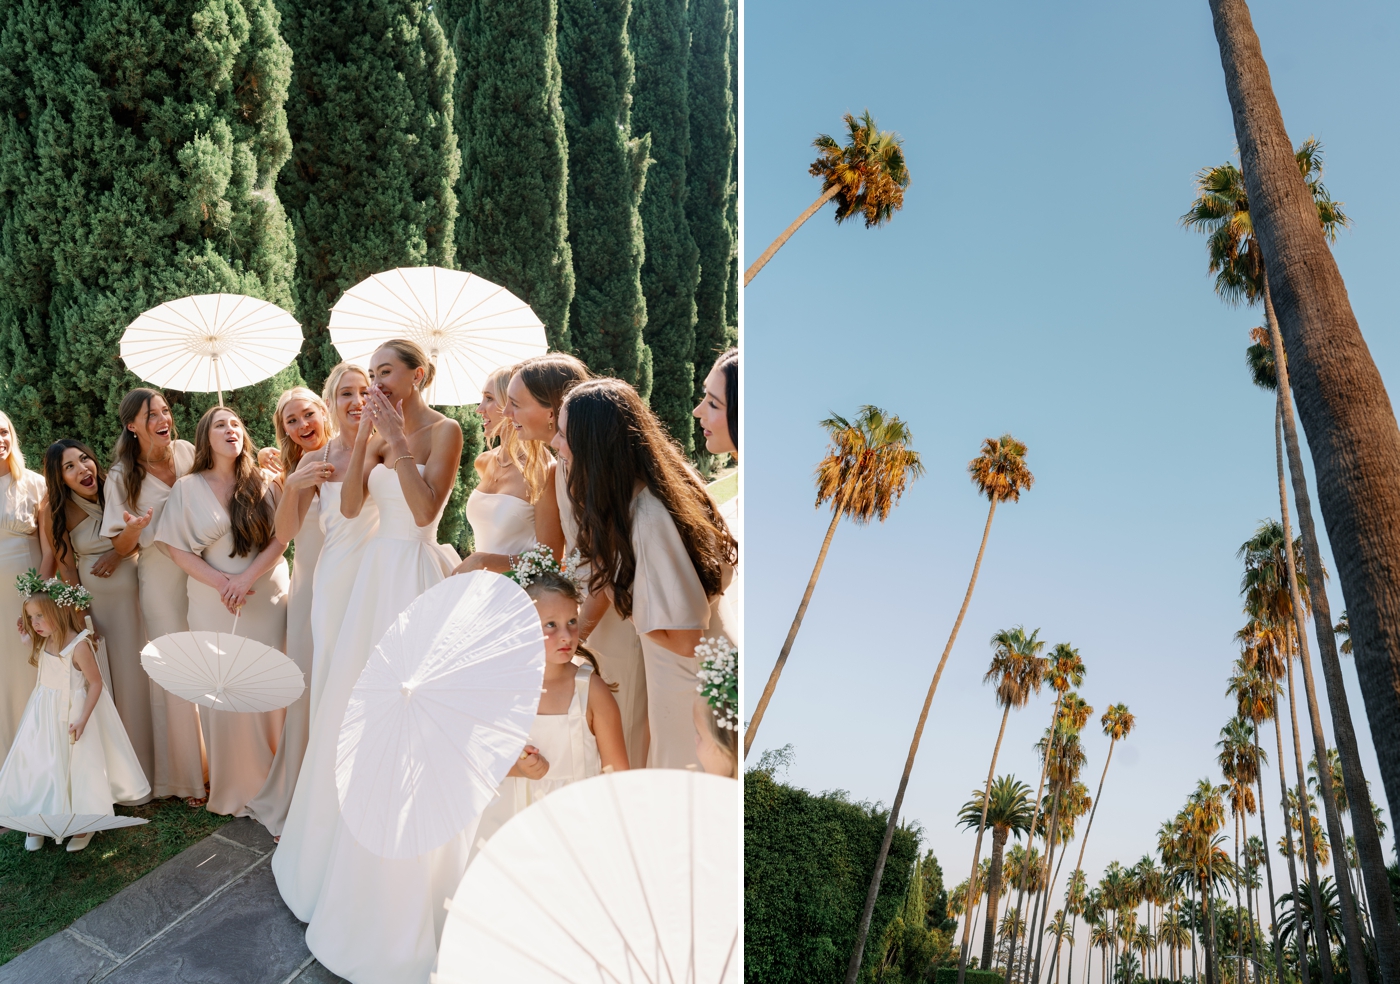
[{"left": 272, "top": 465, "right": 462, "bottom": 984}]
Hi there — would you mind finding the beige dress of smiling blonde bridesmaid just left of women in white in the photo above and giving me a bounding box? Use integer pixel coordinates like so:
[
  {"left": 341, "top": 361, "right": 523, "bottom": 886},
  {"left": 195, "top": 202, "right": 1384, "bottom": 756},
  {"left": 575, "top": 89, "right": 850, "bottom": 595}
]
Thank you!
[{"left": 248, "top": 495, "right": 326, "bottom": 837}]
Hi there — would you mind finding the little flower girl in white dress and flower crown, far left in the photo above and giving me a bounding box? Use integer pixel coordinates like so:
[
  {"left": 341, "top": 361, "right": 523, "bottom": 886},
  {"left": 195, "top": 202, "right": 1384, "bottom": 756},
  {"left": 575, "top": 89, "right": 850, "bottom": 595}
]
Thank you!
[{"left": 0, "top": 570, "right": 151, "bottom": 851}]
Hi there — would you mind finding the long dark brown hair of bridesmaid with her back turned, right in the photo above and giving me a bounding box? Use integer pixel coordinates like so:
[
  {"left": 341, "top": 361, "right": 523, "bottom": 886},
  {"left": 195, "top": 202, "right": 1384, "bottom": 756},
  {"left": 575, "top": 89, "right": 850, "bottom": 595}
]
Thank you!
[{"left": 564, "top": 379, "right": 739, "bottom": 619}]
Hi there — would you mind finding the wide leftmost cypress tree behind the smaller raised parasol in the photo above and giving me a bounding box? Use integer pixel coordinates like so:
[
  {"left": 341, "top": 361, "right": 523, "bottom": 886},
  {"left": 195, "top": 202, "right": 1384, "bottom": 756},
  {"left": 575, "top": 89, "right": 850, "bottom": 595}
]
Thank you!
[{"left": 0, "top": 0, "right": 298, "bottom": 454}]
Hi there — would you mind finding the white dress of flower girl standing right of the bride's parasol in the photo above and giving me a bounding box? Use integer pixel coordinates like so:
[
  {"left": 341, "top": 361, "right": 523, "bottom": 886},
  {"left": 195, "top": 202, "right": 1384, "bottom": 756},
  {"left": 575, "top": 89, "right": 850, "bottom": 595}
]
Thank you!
[{"left": 472, "top": 663, "right": 602, "bottom": 857}]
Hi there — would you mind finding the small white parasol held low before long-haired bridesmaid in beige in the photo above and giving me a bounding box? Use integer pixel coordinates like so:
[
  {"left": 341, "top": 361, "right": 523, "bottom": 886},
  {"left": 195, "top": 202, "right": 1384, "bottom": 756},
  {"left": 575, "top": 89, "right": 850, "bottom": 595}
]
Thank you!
[{"left": 141, "top": 635, "right": 307, "bottom": 711}]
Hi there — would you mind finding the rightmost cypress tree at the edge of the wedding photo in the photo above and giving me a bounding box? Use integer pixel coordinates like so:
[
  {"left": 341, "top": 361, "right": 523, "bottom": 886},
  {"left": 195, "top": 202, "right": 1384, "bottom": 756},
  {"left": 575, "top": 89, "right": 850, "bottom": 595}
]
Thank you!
[{"left": 686, "top": 0, "right": 736, "bottom": 451}]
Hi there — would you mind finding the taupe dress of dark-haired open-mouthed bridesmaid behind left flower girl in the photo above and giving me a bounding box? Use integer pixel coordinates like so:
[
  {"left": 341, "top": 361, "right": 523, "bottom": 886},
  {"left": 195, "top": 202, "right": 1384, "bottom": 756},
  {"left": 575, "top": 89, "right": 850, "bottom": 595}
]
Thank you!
[{"left": 69, "top": 495, "right": 155, "bottom": 782}]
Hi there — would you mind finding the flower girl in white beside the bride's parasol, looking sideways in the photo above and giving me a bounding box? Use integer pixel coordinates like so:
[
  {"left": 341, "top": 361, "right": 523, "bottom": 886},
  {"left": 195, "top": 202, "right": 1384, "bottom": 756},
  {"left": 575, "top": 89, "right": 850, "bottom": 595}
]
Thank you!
[{"left": 473, "top": 565, "right": 627, "bottom": 854}]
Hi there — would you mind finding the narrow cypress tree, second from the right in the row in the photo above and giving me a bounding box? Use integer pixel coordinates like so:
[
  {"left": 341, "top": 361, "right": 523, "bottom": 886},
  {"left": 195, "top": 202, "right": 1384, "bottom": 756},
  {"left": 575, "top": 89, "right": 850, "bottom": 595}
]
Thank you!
[{"left": 631, "top": 0, "right": 700, "bottom": 452}]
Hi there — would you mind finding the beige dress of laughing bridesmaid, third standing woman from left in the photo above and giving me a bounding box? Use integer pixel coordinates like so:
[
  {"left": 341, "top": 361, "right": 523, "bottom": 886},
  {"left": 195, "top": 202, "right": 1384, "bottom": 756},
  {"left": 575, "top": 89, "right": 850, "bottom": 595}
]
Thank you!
[{"left": 102, "top": 441, "right": 209, "bottom": 799}]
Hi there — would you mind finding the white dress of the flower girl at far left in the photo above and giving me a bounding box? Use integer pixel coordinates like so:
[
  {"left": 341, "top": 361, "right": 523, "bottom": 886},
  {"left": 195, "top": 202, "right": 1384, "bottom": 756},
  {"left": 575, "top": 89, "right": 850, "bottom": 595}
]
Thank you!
[{"left": 0, "top": 630, "right": 151, "bottom": 816}]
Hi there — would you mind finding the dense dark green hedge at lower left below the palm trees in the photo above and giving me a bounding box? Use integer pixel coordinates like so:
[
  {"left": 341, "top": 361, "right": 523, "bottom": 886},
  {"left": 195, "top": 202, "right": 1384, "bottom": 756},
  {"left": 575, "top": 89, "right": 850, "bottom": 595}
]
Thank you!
[{"left": 743, "top": 770, "right": 918, "bottom": 984}]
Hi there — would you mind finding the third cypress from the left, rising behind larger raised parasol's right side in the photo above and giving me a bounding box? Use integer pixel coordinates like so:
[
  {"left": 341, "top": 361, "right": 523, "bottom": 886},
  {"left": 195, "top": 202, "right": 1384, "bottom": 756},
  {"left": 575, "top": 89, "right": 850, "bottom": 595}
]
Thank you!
[{"left": 444, "top": 0, "right": 574, "bottom": 351}]
